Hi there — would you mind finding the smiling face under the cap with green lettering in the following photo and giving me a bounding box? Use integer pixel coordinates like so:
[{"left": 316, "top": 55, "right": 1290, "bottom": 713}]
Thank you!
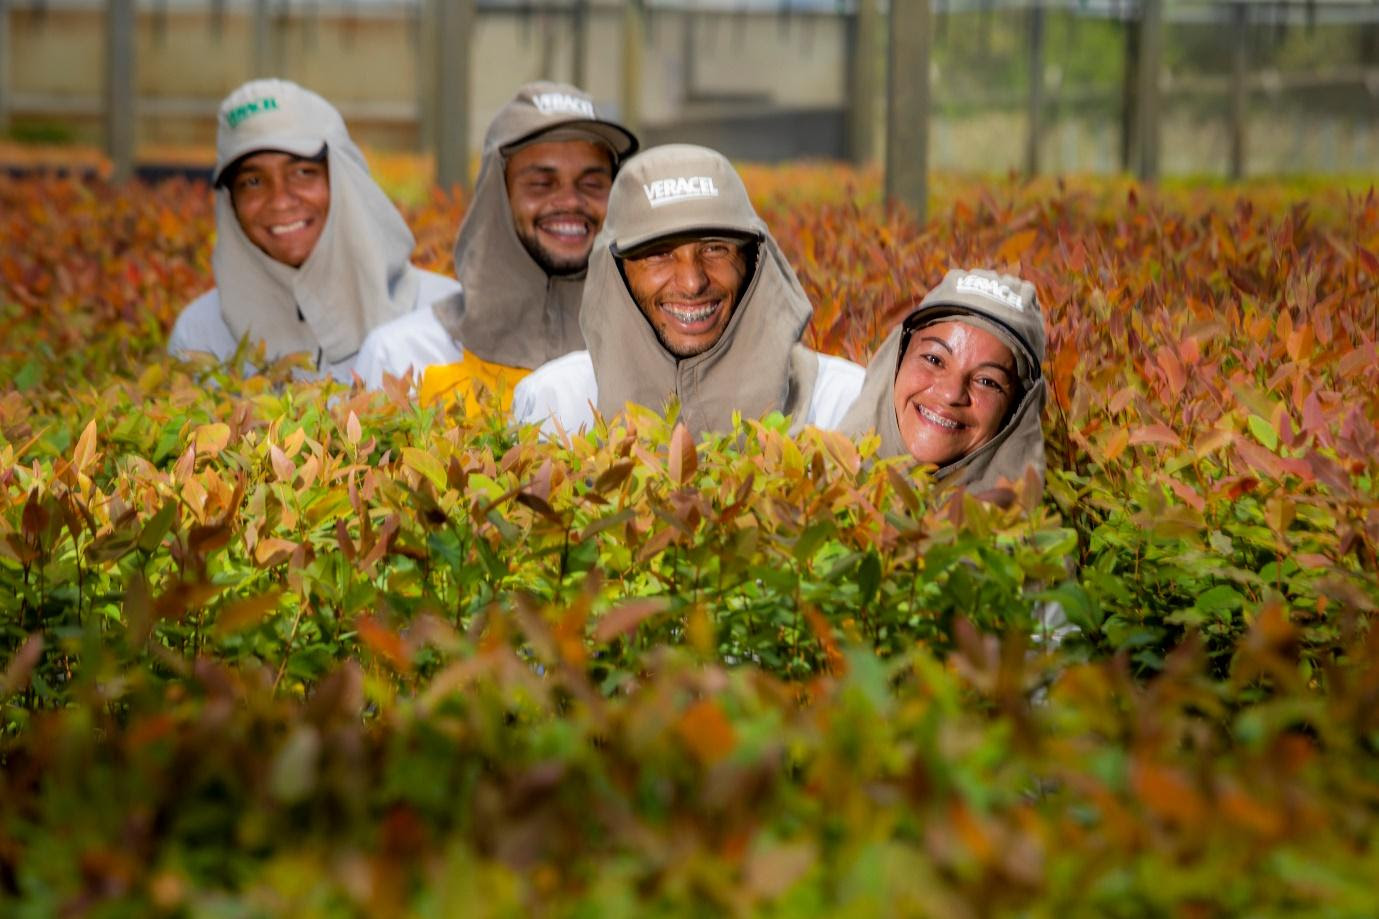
[{"left": 230, "top": 150, "right": 331, "bottom": 268}]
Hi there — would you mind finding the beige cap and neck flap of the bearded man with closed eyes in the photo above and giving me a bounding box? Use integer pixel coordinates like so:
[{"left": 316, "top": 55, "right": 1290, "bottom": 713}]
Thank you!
[{"left": 436, "top": 81, "right": 637, "bottom": 368}]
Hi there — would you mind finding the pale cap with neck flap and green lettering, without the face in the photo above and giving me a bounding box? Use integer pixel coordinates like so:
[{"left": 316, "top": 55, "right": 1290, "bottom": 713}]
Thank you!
[{"left": 211, "top": 80, "right": 421, "bottom": 363}]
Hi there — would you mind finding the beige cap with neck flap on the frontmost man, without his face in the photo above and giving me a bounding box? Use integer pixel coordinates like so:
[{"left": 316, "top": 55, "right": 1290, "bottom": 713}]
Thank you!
[{"left": 581, "top": 145, "right": 816, "bottom": 436}]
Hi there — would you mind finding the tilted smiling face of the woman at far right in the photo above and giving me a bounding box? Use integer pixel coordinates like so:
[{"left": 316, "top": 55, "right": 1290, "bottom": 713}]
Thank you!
[{"left": 895, "top": 322, "right": 1018, "bottom": 466}]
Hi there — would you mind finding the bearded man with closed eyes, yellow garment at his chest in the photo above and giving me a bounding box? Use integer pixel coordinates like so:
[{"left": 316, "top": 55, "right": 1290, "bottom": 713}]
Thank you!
[{"left": 360, "top": 81, "right": 637, "bottom": 411}]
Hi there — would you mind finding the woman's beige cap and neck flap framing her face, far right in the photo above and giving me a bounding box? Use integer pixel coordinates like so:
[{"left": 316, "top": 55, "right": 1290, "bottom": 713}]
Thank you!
[{"left": 840, "top": 269, "right": 1045, "bottom": 491}]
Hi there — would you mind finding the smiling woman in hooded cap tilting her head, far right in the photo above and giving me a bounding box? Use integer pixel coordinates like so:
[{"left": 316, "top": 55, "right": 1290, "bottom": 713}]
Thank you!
[{"left": 843, "top": 269, "right": 1044, "bottom": 490}]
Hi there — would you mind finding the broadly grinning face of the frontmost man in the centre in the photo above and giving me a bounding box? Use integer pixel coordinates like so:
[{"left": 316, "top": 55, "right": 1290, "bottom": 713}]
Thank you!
[{"left": 622, "top": 237, "right": 747, "bottom": 357}]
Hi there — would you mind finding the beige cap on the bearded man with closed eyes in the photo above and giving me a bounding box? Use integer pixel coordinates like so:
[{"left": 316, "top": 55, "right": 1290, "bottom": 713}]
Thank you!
[{"left": 484, "top": 80, "right": 637, "bottom": 161}]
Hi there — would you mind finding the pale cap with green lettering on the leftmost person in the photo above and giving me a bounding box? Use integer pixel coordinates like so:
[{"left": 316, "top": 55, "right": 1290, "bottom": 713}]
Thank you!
[{"left": 211, "top": 79, "right": 349, "bottom": 185}]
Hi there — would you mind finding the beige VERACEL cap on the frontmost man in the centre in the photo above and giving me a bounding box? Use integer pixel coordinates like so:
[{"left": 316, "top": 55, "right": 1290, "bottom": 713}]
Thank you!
[{"left": 604, "top": 144, "right": 765, "bottom": 258}]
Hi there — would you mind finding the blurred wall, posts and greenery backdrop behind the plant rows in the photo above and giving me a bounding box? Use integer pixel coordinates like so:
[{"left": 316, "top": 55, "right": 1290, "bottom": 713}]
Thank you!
[{"left": 0, "top": 0, "right": 1379, "bottom": 187}]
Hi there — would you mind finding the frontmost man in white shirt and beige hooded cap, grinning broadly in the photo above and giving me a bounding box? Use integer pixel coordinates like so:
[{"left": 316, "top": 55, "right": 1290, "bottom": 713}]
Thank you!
[{"left": 513, "top": 144, "right": 863, "bottom": 435}]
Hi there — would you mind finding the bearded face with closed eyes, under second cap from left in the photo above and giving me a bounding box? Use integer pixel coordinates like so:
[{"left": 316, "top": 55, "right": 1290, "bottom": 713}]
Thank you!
[{"left": 505, "top": 141, "right": 612, "bottom": 275}]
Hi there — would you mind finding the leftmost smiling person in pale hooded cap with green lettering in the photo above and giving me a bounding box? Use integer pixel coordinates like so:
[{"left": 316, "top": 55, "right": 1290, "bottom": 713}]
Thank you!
[{"left": 168, "top": 80, "right": 458, "bottom": 382}]
